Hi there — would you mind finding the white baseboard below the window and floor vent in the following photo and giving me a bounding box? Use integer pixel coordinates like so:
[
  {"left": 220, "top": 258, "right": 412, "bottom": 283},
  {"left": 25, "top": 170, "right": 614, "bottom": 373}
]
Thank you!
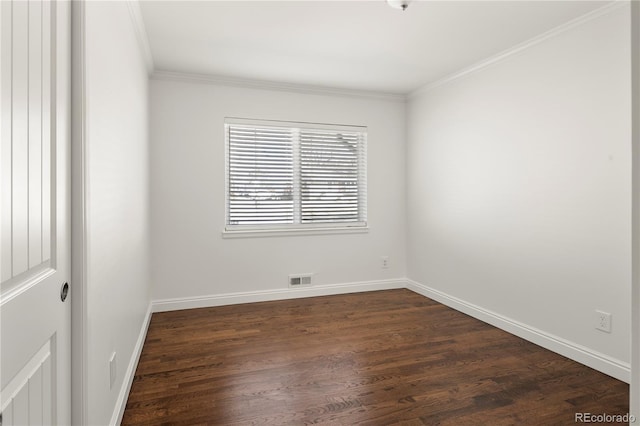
[{"left": 152, "top": 278, "right": 406, "bottom": 312}]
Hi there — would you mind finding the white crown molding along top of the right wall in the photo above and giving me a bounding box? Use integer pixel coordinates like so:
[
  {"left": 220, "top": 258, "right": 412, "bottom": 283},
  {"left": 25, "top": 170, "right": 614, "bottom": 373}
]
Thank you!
[{"left": 406, "top": 0, "right": 630, "bottom": 100}]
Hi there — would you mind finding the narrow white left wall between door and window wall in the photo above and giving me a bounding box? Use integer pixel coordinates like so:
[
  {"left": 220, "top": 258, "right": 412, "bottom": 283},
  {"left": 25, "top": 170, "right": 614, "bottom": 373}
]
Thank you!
[{"left": 85, "top": 2, "right": 150, "bottom": 425}]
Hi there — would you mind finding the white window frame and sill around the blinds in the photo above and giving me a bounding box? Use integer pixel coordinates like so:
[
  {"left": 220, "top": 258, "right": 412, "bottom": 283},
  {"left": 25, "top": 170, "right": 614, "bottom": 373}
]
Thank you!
[{"left": 222, "top": 117, "right": 369, "bottom": 238}]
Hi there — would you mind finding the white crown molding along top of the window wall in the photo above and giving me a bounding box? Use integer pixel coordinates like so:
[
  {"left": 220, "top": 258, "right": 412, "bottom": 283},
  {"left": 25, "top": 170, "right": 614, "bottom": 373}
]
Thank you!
[{"left": 151, "top": 70, "right": 406, "bottom": 102}]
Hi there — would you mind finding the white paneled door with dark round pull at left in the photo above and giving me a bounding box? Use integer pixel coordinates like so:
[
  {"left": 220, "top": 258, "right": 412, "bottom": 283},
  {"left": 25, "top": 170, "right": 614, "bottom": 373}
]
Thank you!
[{"left": 0, "top": 0, "right": 71, "bottom": 426}]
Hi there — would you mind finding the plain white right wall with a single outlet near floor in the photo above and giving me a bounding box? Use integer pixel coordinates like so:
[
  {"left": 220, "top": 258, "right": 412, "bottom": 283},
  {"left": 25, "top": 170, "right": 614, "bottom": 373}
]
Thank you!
[{"left": 407, "top": 5, "right": 631, "bottom": 374}]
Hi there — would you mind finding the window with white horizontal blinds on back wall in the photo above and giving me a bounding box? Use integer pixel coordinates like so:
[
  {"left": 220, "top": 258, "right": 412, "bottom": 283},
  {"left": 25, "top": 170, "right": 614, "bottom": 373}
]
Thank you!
[{"left": 225, "top": 119, "right": 367, "bottom": 232}]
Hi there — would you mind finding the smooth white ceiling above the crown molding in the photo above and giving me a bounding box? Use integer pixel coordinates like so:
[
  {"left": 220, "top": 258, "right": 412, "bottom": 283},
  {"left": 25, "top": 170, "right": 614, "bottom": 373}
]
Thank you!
[{"left": 141, "top": 0, "right": 609, "bottom": 94}]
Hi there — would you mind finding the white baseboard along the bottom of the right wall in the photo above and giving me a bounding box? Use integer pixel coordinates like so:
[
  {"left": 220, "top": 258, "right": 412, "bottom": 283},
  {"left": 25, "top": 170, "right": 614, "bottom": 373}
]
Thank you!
[{"left": 406, "top": 279, "right": 631, "bottom": 383}]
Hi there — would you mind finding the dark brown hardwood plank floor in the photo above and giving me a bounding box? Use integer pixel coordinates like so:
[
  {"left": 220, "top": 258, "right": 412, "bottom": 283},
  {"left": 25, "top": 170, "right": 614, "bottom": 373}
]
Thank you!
[{"left": 122, "top": 290, "right": 629, "bottom": 426}]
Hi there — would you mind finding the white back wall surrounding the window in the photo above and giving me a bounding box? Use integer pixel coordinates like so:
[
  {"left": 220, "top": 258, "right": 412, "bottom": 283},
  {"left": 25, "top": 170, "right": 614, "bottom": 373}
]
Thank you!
[{"left": 150, "top": 79, "right": 406, "bottom": 307}]
